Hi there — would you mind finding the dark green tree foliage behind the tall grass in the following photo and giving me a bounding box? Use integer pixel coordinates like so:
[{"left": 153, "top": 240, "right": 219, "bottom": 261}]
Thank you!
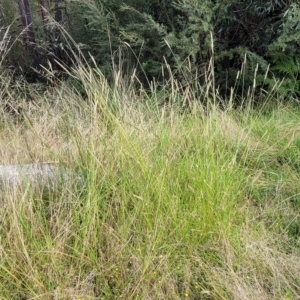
[{"left": 0, "top": 0, "right": 300, "bottom": 99}]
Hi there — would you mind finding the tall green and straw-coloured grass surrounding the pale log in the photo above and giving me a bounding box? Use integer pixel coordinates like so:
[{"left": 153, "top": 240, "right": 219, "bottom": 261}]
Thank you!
[{"left": 0, "top": 63, "right": 300, "bottom": 300}]
